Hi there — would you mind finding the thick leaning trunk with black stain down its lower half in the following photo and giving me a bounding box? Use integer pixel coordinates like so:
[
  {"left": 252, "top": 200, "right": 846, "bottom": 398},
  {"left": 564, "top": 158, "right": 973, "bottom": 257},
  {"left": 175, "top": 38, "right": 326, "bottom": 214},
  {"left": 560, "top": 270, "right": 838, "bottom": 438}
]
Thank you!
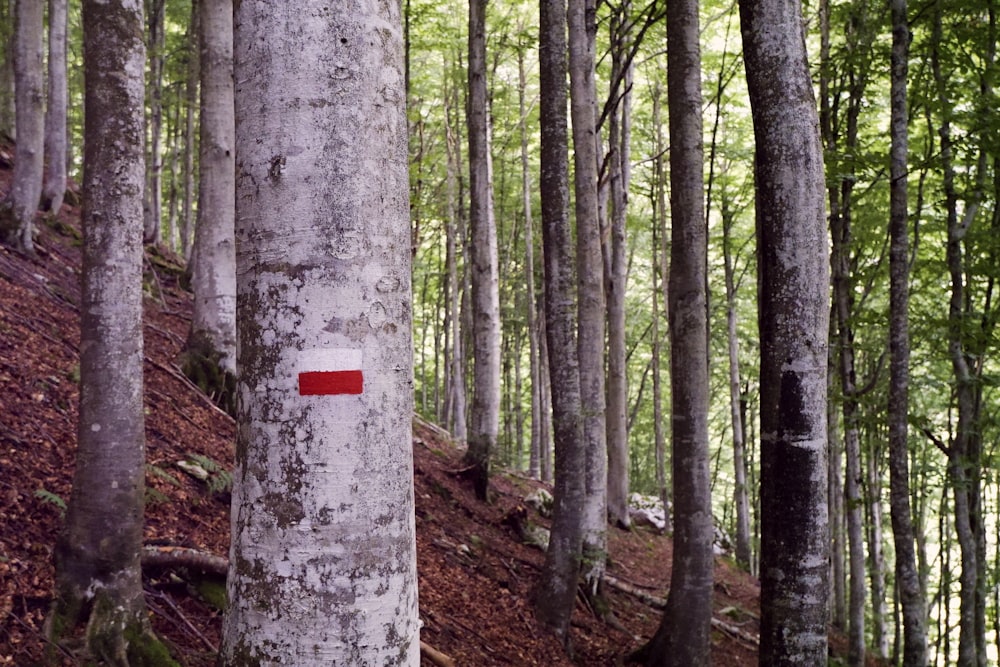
[{"left": 740, "top": 0, "right": 830, "bottom": 667}]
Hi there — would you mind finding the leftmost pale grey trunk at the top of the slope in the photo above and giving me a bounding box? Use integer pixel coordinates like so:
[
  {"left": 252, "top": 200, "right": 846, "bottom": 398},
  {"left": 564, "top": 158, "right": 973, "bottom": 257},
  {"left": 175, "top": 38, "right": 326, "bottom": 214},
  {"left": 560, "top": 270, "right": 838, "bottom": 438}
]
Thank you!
[{"left": 0, "top": 0, "right": 45, "bottom": 255}]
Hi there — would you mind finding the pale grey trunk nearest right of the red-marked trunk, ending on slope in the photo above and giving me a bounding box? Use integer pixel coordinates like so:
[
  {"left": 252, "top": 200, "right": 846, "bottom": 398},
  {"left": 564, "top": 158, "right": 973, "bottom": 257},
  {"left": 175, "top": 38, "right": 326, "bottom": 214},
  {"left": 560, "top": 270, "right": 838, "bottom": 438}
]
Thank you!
[{"left": 467, "top": 0, "right": 500, "bottom": 500}]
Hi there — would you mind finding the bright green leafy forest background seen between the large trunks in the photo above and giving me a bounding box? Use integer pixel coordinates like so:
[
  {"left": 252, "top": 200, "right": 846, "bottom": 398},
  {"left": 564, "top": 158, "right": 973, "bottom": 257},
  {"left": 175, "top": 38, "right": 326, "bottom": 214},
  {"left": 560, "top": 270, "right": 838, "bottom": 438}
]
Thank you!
[{"left": 0, "top": 0, "right": 1000, "bottom": 664}]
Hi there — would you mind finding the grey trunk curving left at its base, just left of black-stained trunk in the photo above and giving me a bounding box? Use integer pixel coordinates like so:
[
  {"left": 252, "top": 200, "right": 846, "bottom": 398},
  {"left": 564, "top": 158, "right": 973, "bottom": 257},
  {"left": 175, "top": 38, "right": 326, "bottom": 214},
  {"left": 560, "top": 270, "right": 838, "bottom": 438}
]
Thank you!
[{"left": 646, "top": 0, "right": 715, "bottom": 667}]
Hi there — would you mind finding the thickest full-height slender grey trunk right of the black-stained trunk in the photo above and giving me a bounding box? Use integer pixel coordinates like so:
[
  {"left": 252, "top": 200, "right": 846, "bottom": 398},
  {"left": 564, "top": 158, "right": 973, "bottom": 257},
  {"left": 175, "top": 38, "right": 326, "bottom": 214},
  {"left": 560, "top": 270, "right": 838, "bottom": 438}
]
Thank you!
[{"left": 887, "top": 0, "right": 927, "bottom": 666}]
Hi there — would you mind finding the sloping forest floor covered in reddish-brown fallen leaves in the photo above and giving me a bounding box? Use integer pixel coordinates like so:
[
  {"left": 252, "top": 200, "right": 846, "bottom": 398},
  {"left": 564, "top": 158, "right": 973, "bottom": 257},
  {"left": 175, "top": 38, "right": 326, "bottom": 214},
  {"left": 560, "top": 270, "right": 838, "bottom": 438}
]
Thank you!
[{"left": 0, "top": 153, "right": 856, "bottom": 667}]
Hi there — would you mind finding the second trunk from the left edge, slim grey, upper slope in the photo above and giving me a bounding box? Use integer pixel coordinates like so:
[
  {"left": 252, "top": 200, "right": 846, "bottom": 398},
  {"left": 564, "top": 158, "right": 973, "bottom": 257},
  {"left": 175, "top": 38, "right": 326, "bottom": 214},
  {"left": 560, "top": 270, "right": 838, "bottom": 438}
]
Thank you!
[{"left": 42, "top": 0, "right": 67, "bottom": 214}]
